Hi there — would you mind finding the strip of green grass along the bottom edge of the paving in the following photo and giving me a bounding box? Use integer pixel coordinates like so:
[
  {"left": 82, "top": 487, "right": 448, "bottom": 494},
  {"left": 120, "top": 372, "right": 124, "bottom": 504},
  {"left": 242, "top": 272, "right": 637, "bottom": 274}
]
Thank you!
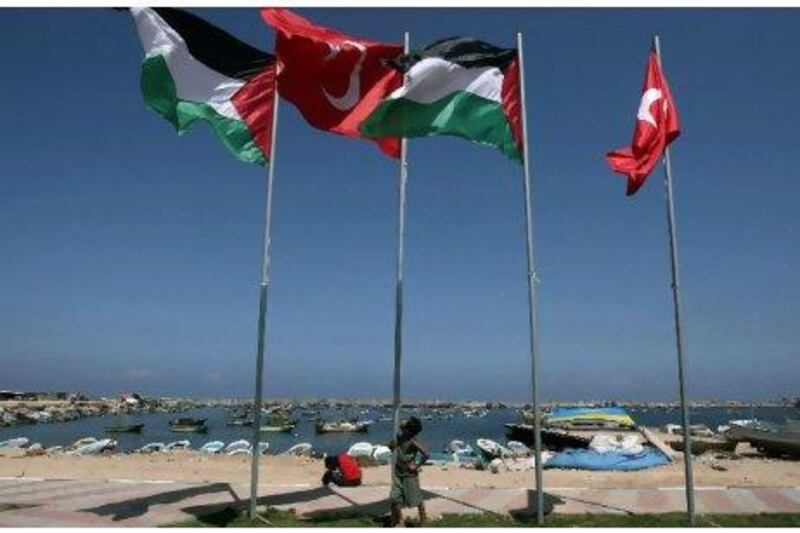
[{"left": 169, "top": 508, "right": 800, "bottom": 527}]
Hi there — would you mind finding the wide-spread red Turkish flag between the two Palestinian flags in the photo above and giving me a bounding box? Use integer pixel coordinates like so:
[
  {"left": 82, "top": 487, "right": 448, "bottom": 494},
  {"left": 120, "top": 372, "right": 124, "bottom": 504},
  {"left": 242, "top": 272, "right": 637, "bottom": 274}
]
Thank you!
[{"left": 261, "top": 8, "right": 403, "bottom": 158}]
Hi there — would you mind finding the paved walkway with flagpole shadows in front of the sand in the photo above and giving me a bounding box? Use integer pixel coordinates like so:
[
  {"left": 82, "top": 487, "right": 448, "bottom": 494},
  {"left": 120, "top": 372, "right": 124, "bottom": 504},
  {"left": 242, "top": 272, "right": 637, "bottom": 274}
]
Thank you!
[{"left": 0, "top": 478, "right": 800, "bottom": 527}]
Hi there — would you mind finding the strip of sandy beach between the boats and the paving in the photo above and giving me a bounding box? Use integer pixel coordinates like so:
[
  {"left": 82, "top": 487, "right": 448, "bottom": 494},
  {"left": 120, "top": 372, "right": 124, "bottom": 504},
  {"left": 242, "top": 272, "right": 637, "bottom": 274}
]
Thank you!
[{"left": 0, "top": 446, "right": 800, "bottom": 488}]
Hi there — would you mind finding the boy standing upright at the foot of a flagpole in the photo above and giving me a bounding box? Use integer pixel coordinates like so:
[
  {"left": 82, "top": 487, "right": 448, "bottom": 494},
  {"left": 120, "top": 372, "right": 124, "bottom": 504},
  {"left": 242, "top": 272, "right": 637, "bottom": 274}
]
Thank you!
[{"left": 389, "top": 416, "right": 428, "bottom": 527}]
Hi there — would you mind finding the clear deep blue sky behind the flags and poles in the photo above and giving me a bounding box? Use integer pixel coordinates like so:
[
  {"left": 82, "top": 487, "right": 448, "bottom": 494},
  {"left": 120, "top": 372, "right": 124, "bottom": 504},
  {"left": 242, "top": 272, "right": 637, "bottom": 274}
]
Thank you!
[{"left": 0, "top": 9, "right": 800, "bottom": 400}]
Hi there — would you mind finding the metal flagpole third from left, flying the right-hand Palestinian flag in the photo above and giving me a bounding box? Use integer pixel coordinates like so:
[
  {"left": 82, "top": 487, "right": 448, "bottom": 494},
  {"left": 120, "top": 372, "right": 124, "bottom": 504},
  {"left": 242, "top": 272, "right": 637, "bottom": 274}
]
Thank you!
[{"left": 517, "top": 32, "right": 544, "bottom": 526}]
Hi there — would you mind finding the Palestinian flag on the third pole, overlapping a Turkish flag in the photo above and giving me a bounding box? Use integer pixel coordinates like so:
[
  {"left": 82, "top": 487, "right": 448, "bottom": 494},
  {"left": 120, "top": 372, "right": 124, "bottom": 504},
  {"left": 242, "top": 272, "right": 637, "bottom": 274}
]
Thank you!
[{"left": 361, "top": 37, "right": 523, "bottom": 161}]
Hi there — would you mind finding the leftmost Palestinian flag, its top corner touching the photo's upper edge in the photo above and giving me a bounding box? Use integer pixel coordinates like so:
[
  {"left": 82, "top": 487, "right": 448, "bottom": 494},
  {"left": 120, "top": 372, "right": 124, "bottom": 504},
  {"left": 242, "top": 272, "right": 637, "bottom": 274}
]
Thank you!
[{"left": 131, "top": 7, "right": 275, "bottom": 165}]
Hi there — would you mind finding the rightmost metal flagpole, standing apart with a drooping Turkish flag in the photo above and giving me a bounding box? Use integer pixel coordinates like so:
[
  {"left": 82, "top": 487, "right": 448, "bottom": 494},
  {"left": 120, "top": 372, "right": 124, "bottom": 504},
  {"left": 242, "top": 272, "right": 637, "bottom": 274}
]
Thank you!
[{"left": 653, "top": 35, "right": 695, "bottom": 525}]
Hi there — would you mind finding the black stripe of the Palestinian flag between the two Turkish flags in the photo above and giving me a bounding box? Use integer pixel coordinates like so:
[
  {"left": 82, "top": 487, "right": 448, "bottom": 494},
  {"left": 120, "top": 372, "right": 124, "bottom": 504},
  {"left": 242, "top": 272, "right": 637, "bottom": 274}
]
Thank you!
[{"left": 391, "top": 37, "right": 517, "bottom": 72}]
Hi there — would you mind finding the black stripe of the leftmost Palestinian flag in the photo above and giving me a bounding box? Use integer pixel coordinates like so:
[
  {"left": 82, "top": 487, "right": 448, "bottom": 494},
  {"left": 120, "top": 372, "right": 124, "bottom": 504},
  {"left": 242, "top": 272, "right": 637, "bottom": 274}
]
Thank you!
[{"left": 153, "top": 7, "right": 275, "bottom": 80}]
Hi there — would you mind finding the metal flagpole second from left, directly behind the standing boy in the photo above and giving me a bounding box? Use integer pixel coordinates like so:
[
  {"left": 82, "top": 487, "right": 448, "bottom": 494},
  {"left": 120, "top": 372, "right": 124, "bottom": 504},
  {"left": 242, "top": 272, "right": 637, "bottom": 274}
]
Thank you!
[{"left": 392, "top": 32, "right": 409, "bottom": 516}]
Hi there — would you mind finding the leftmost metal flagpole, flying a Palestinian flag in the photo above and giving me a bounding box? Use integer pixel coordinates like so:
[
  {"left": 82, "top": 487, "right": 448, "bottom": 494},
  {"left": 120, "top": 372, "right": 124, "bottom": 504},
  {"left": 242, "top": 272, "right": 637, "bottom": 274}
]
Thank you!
[{"left": 250, "top": 87, "right": 280, "bottom": 519}]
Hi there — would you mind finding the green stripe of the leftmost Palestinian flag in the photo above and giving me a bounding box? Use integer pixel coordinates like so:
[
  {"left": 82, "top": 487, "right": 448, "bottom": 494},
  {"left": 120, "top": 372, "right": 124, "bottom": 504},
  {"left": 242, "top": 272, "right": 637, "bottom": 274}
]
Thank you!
[{"left": 142, "top": 55, "right": 267, "bottom": 166}]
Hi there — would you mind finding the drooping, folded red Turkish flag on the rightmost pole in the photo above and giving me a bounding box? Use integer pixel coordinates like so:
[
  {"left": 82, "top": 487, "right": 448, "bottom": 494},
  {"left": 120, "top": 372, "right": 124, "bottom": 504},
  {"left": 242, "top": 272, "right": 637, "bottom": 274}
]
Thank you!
[{"left": 606, "top": 50, "right": 681, "bottom": 196}]
